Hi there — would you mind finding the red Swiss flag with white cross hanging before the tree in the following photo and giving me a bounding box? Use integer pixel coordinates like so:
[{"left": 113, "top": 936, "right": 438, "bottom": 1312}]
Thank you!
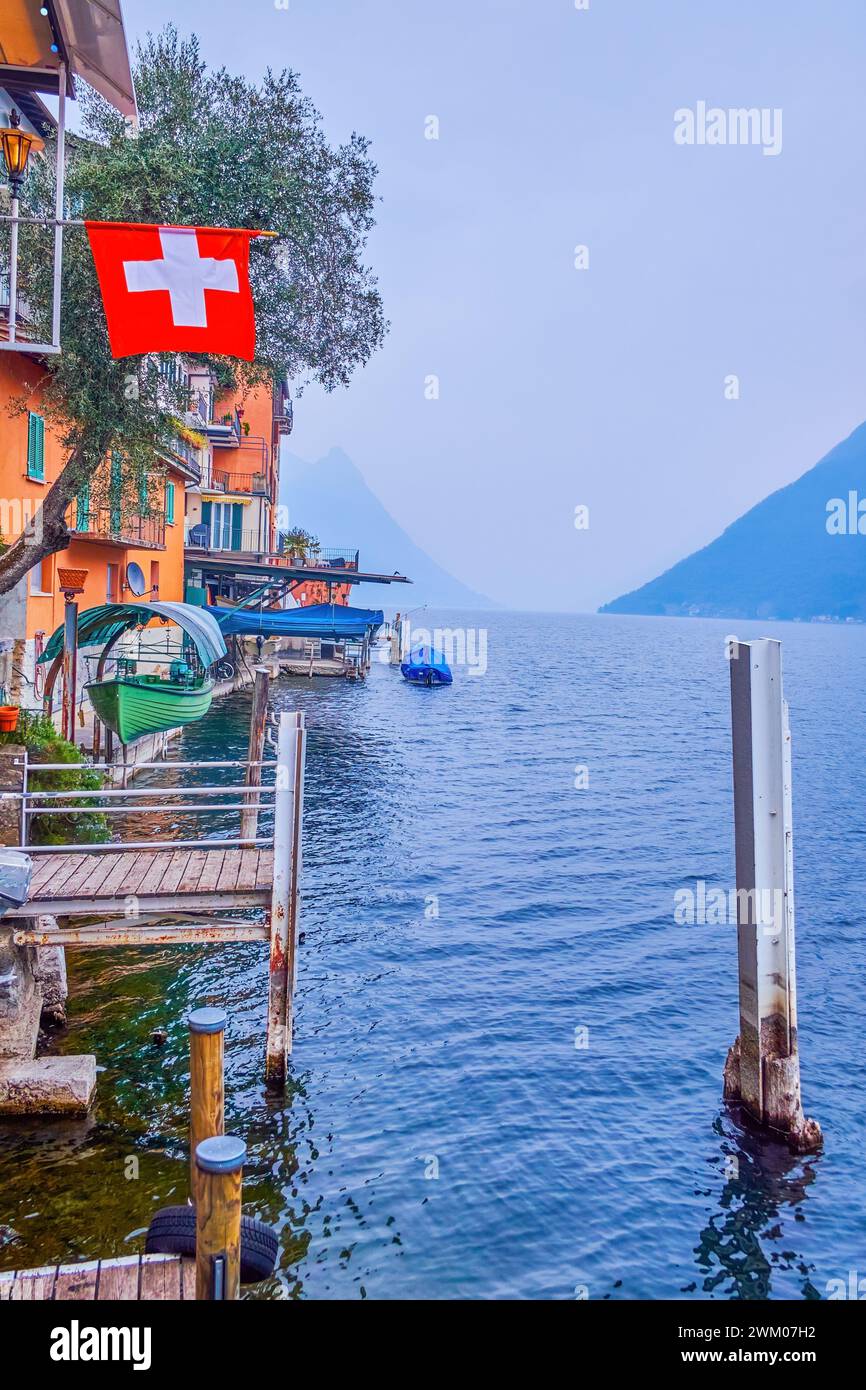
[{"left": 85, "top": 222, "right": 259, "bottom": 361}]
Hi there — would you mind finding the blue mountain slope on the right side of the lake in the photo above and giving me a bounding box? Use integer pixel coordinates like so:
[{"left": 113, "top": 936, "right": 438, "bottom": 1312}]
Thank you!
[{"left": 599, "top": 424, "right": 866, "bottom": 621}]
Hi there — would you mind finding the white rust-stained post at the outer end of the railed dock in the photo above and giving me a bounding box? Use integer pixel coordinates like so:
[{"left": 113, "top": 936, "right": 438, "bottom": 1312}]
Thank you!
[{"left": 264, "top": 713, "right": 306, "bottom": 1087}]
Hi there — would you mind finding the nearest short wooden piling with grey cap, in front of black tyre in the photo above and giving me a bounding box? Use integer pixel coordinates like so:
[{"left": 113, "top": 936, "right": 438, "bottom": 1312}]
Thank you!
[{"left": 196, "top": 1134, "right": 246, "bottom": 1300}]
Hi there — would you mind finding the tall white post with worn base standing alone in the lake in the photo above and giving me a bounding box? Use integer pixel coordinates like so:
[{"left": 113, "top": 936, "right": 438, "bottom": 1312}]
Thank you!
[{"left": 724, "top": 638, "right": 822, "bottom": 1152}]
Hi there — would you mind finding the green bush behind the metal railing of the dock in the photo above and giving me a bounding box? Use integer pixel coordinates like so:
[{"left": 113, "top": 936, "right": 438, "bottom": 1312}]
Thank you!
[{"left": 0, "top": 709, "right": 108, "bottom": 845}]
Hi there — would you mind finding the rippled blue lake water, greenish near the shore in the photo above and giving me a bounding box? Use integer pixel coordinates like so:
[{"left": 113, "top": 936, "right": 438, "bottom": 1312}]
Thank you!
[{"left": 0, "top": 613, "right": 866, "bottom": 1298}]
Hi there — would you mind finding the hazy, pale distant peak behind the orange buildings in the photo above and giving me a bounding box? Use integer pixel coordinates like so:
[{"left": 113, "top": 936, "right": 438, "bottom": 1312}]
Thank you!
[{"left": 279, "top": 449, "right": 496, "bottom": 609}]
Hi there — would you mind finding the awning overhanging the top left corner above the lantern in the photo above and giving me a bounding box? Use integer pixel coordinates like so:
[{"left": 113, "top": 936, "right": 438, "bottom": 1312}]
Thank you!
[{"left": 0, "top": 0, "right": 136, "bottom": 115}]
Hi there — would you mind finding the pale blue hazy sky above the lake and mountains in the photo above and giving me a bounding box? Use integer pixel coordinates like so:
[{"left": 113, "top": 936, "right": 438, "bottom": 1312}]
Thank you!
[{"left": 124, "top": 0, "right": 866, "bottom": 609}]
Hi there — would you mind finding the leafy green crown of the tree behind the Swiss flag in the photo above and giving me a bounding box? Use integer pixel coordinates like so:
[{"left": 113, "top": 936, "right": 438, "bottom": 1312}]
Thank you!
[{"left": 12, "top": 26, "right": 386, "bottom": 481}]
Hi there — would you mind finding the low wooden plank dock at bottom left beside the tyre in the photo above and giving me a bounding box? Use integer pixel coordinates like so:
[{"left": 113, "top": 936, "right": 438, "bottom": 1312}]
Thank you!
[{"left": 0, "top": 1255, "right": 196, "bottom": 1302}]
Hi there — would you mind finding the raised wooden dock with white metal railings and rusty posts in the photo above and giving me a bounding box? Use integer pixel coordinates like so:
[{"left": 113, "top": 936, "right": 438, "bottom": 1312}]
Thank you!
[{"left": 4, "top": 689, "right": 306, "bottom": 1086}]
